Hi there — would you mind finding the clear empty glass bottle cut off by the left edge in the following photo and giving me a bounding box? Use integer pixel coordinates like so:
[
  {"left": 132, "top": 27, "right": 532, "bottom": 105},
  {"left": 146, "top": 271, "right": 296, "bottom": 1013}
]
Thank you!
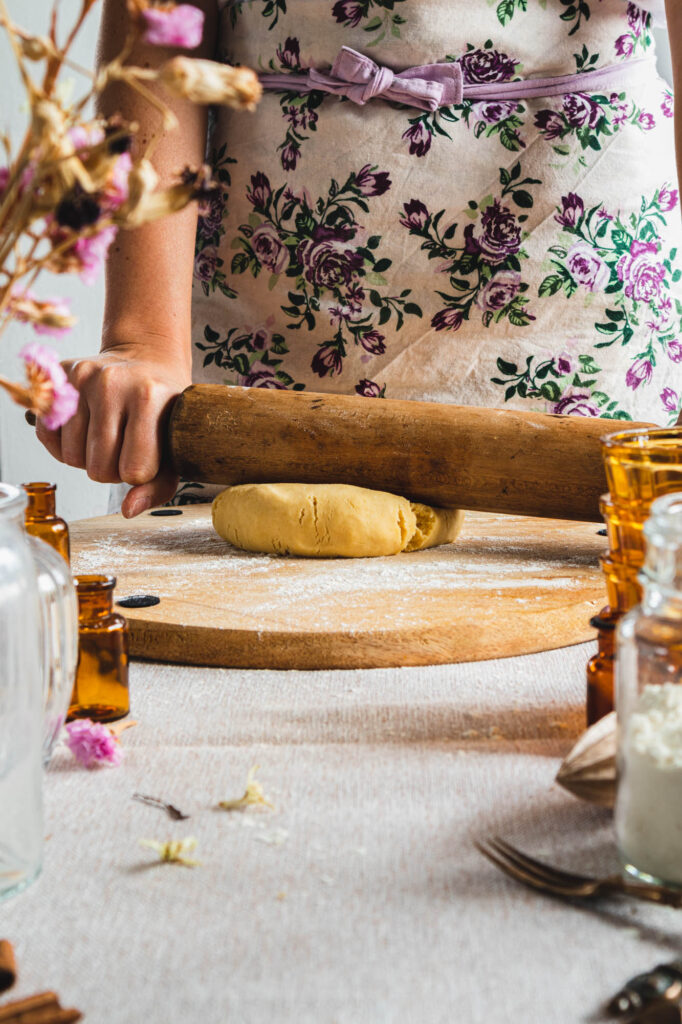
[{"left": 0, "top": 484, "right": 43, "bottom": 899}]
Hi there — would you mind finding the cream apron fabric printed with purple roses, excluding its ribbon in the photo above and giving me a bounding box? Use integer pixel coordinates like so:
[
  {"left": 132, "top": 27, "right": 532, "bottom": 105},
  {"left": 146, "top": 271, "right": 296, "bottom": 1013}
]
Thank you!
[{"left": 184, "top": 0, "right": 682, "bottom": 440}]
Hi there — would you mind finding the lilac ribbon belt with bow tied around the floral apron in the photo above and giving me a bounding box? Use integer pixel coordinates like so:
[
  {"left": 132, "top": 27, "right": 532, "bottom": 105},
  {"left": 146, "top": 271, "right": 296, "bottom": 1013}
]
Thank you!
[{"left": 260, "top": 46, "right": 652, "bottom": 111}]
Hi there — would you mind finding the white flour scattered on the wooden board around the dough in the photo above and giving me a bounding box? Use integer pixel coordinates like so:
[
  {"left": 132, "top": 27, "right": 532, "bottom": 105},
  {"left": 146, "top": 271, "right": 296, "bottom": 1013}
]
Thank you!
[{"left": 73, "top": 507, "right": 597, "bottom": 630}]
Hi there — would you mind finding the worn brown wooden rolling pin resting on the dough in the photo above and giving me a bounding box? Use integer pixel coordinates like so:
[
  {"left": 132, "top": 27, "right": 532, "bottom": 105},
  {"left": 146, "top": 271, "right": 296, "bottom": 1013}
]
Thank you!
[{"left": 170, "top": 384, "right": 638, "bottom": 522}]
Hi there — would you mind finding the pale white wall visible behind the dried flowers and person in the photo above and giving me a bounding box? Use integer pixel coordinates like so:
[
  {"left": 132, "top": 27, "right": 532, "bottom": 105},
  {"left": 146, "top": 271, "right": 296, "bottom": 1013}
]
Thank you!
[{"left": 0, "top": 0, "right": 672, "bottom": 519}]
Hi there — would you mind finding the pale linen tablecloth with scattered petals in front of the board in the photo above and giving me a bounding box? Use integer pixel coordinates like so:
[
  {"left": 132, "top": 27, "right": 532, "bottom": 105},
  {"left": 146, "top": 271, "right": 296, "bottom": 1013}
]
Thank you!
[{"left": 5, "top": 645, "right": 682, "bottom": 1024}]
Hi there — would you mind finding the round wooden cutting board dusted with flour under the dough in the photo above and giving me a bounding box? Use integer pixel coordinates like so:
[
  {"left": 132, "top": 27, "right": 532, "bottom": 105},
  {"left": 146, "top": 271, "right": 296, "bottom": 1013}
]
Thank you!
[{"left": 71, "top": 505, "right": 606, "bottom": 669}]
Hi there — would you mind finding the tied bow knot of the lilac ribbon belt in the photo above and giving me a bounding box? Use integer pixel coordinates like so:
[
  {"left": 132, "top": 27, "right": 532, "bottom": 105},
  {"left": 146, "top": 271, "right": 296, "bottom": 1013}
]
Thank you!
[{"left": 308, "top": 46, "right": 464, "bottom": 111}]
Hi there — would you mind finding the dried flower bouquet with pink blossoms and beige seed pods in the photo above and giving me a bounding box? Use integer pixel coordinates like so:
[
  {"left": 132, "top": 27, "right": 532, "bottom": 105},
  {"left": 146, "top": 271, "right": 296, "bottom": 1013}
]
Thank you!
[{"left": 0, "top": 0, "right": 260, "bottom": 430}]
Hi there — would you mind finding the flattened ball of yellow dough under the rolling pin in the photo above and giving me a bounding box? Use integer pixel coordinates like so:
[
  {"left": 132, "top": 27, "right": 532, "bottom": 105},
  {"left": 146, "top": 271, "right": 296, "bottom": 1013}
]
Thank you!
[{"left": 213, "top": 483, "right": 463, "bottom": 558}]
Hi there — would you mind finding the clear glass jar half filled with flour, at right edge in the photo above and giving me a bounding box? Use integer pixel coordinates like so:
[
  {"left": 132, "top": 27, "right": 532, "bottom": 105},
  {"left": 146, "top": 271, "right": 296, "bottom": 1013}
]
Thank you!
[{"left": 615, "top": 494, "right": 682, "bottom": 887}]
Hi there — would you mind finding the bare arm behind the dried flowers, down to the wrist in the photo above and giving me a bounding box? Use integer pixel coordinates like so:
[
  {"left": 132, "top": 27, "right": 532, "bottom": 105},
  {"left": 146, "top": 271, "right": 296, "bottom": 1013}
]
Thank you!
[{"left": 99, "top": 0, "right": 216, "bottom": 366}]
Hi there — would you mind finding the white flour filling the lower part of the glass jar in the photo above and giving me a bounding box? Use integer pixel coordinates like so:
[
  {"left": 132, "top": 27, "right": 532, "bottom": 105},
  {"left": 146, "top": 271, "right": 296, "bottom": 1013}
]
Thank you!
[{"left": 616, "top": 683, "right": 682, "bottom": 885}]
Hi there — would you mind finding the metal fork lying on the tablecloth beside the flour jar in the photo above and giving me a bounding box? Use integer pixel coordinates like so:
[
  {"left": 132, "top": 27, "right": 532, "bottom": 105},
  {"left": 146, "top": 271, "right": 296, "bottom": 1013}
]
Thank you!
[{"left": 475, "top": 836, "right": 682, "bottom": 907}]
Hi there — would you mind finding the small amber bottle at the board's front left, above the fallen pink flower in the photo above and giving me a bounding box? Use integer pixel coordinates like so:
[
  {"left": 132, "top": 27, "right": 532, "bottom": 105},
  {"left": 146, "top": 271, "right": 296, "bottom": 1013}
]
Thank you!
[{"left": 68, "top": 575, "right": 130, "bottom": 722}]
